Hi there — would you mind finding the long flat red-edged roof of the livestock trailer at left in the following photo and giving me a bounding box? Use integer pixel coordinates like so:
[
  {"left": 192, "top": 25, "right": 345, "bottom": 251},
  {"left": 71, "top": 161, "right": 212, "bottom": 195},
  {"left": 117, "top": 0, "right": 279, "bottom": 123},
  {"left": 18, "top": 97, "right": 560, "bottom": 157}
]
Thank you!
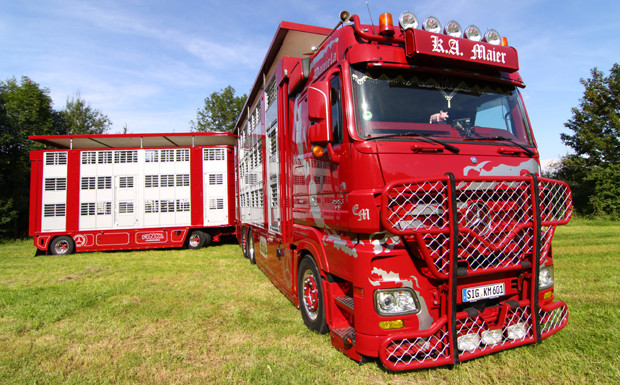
[{"left": 29, "top": 132, "right": 237, "bottom": 149}]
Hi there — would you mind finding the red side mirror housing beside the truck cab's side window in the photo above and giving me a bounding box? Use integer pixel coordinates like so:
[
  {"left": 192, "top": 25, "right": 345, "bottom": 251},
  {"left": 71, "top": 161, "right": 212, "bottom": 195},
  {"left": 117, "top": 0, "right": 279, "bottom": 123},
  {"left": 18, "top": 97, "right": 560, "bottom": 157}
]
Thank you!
[{"left": 308, "top": 81, "right": 333, "bottom": 144}]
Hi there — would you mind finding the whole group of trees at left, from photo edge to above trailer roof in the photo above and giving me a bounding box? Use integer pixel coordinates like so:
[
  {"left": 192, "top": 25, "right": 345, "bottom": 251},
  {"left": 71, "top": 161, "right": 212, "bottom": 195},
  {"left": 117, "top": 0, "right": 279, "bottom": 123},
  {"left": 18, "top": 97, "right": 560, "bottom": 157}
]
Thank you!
[{"left": 0, "top": 76, "right": 112, "bottom": 238}]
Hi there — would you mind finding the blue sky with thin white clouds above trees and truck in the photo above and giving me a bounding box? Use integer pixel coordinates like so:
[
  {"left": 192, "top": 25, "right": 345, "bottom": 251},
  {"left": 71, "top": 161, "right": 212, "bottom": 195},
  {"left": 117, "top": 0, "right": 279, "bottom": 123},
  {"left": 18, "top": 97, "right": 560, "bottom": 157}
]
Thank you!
[{"left": 0, "top": 0, "right": 620, "bottom": 159}]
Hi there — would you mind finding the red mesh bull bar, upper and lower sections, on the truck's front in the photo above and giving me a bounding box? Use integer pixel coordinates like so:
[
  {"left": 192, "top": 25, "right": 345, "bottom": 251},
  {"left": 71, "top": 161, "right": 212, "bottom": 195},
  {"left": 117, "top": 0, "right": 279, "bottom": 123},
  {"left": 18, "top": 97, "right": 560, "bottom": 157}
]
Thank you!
[{"left": 379, "top": 174, "right": 572, "bottom": 370}]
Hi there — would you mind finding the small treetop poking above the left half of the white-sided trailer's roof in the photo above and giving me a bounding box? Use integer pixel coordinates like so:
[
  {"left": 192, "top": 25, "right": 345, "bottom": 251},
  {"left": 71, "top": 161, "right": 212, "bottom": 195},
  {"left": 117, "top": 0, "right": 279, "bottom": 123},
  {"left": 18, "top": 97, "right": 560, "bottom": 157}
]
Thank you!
[{"left": 60, "top": 92, "right": 112, "bottom": 135}]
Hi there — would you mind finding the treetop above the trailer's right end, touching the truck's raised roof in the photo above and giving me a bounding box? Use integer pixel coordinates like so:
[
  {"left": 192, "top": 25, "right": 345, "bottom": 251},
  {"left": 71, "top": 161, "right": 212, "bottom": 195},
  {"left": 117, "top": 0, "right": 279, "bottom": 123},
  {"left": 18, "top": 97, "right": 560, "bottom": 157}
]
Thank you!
[{"left": 190, "top": 86, "right": 247, "bottom": 132}]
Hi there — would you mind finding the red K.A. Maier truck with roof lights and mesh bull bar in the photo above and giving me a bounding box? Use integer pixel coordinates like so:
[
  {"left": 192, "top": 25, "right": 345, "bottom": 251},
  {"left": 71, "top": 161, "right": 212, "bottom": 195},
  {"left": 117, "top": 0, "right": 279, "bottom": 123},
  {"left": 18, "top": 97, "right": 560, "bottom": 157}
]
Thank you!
[{"left": 236, "top": 12, "right": 572, "bottom": 370}]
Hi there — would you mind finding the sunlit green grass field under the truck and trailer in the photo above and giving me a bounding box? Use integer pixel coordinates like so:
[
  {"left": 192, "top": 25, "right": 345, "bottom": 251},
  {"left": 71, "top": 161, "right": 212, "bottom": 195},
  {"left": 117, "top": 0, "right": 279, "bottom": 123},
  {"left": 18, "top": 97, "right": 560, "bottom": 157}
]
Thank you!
[{"left": 0, "top": 220, "right": 620, "bottom": 384}]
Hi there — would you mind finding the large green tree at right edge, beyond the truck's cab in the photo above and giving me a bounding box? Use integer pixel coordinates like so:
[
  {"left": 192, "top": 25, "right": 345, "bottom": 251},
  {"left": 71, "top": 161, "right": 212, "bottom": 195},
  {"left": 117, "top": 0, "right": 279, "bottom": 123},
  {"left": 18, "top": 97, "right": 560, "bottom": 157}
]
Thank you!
[{"left": 555, "top": 63, "right": 620, "bottom": 219}]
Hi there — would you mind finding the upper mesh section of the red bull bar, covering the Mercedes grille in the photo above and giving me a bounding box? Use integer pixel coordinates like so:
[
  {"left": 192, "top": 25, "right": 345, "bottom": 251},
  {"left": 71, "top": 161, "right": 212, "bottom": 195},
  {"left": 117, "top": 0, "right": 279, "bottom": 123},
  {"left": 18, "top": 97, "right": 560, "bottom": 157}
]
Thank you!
[{"left": 382, "top": 176, "right": 572, "bottom": 279}]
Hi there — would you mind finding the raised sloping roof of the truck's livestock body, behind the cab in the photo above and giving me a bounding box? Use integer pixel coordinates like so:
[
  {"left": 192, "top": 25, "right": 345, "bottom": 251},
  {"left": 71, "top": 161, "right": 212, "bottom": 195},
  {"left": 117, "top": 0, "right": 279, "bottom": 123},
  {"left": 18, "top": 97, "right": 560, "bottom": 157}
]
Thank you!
[{"left": 235, "top": 21, "right": 331, "bottom": 130}]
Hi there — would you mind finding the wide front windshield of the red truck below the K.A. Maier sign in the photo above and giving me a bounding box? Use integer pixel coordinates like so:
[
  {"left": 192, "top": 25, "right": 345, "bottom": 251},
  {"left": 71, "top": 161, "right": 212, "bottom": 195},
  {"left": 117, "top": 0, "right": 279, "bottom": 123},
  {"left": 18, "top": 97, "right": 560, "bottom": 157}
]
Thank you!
[{"left": 352, "top": 69, "right": 533, "bottom": 145}]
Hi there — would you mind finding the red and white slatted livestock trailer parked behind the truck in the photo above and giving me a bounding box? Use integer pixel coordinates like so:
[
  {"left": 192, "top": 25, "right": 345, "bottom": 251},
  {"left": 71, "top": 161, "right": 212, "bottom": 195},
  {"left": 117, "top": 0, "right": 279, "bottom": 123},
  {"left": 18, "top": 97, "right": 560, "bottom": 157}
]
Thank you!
[{"left": 29, "top": 133, "right": 237, "bottom": 254}]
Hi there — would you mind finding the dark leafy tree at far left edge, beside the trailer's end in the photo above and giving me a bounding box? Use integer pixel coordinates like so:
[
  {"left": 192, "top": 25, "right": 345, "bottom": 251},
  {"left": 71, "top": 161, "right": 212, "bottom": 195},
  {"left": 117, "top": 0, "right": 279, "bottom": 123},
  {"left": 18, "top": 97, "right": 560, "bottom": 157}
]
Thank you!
[{"left": 0, "top": 76, "right": 60, "bottom": 237}]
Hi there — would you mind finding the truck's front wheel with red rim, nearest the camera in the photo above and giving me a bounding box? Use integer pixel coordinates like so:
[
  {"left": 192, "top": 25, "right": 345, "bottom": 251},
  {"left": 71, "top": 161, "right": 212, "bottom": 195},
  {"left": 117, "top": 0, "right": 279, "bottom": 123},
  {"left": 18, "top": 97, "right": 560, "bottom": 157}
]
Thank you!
[{"left": 297, "top": 256, "right": 328, "bottom": 334}]
